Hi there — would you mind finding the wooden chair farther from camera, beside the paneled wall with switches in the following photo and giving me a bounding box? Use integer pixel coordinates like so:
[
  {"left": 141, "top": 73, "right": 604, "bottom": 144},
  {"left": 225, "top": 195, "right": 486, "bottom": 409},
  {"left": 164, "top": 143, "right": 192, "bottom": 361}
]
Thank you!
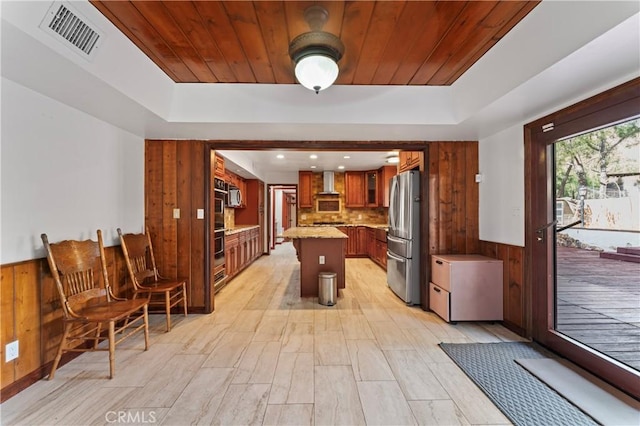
[{"left": 118, "top": 228, "right": 187, "bottom": 331}]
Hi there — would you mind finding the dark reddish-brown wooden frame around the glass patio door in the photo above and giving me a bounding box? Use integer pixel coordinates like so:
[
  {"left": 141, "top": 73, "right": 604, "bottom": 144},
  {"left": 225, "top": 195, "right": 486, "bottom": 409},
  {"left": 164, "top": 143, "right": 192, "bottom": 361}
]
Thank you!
[{"left": 524, "top": 78, "right": 640, "bottom": 398}]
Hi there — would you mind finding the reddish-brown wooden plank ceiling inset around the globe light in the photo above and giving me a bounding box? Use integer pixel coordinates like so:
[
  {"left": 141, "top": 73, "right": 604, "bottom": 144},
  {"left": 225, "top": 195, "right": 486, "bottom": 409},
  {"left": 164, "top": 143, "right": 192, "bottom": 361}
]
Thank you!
[{"left": 91, "top": 0, "right": 539, "bottom": 86}]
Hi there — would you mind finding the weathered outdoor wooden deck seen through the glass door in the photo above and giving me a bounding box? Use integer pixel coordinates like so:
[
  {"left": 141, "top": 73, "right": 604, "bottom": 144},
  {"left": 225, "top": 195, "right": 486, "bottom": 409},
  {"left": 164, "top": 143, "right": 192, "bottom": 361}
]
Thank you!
[{"left": 556, "top": 247, "right": 640, "bottom": 370}]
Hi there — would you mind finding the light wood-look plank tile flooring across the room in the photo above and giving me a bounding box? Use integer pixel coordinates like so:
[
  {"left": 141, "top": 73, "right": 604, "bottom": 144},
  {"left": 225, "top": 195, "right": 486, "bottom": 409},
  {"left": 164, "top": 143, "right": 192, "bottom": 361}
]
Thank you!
[{"left": 0, "top": 243, "right": 522, "bottom": 425}]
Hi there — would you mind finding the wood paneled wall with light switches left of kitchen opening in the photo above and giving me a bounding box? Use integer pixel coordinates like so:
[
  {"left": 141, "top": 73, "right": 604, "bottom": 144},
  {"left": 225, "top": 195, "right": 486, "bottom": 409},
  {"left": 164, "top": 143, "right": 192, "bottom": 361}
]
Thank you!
[{"left": 144, "top": 140, "right": 206, "bottom": 312}]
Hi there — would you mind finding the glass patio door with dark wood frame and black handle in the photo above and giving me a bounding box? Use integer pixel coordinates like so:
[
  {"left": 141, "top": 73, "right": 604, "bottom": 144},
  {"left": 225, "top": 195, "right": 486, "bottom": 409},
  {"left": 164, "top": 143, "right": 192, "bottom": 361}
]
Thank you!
[{"left": 525, "top": 79, "right": 640, "bottom": 398}]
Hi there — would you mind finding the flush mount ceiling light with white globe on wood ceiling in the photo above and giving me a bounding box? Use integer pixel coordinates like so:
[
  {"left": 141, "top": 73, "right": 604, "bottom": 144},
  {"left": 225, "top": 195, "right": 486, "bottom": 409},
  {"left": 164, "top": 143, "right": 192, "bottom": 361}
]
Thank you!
[{"left": 289, "top": 5, "right": 344, "bottom": 93}]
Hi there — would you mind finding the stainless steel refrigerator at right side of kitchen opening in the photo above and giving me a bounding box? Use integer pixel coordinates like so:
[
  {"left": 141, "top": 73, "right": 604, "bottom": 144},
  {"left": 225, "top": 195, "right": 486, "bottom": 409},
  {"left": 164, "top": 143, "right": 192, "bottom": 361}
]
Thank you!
[{"left": 387, "top": 170, "right": 420, "bottom": 305}]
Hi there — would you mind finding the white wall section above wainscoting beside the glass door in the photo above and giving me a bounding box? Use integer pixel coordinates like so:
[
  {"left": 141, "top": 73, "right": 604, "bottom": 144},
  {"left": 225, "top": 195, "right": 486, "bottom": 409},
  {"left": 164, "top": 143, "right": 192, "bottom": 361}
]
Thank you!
[{"left": 478, "top": 124, "right": 524, "bottom": 247}]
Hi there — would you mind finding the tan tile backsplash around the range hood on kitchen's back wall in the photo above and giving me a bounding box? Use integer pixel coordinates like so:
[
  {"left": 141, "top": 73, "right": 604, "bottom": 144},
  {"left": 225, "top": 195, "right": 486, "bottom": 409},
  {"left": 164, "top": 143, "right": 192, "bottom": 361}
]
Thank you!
[{"left": 298, "top": 172, "right": 388, "bottom": 225}]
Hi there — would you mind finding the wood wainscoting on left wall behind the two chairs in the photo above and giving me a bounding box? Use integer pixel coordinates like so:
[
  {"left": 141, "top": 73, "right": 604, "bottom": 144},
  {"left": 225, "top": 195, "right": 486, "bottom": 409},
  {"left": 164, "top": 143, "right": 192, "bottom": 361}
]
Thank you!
[{"left": 0, "top": 245, "right": 130, "bottom": 401}]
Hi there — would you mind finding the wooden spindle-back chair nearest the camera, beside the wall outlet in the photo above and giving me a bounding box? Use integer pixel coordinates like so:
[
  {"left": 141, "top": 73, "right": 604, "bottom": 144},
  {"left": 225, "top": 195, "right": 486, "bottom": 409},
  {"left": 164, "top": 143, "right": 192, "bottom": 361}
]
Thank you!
[{"left": 41, "top": 230, "right": 149, "bottom": 380}]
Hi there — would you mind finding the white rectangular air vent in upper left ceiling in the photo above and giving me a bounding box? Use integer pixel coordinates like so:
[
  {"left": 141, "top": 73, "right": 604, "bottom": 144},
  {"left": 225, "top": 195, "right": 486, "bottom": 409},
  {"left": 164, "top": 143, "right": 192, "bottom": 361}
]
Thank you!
[{"left": 40, "top": 2, "right": 104, "bottom": 60}]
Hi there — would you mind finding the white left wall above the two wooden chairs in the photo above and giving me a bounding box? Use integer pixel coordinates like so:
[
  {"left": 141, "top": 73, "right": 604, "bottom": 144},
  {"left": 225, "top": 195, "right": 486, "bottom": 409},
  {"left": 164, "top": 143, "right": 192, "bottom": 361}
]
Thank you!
[{"left": 0, "top": 78, "right": 144, "bottom": 264}]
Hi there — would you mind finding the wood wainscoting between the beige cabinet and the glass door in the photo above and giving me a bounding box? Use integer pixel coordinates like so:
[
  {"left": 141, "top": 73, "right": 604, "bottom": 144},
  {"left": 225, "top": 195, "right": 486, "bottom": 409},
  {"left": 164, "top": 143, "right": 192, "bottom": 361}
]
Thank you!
[{"left": 479, "top": 241, "right": 531, "bottom": 337}]
